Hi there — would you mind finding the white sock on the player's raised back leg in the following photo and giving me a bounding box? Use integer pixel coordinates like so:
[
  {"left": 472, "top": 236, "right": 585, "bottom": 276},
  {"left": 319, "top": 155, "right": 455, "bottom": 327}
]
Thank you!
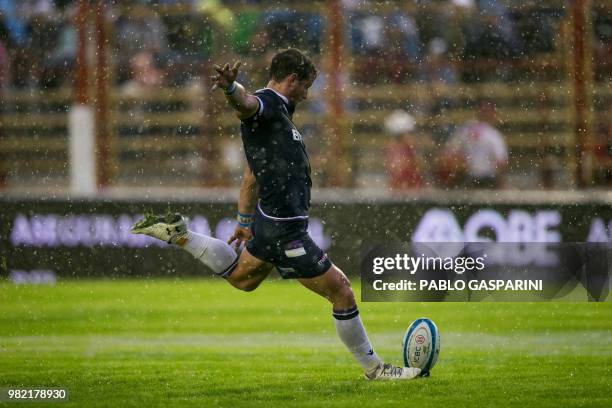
[{"left": 181, "top": 231, "right": 238, "bottom": 278}]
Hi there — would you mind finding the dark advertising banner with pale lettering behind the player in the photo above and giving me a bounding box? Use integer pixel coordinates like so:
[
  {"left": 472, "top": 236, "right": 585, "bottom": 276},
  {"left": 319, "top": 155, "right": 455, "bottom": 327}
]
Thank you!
[{"left": 0, "top": 199, "right": 612, "bottom": 281}]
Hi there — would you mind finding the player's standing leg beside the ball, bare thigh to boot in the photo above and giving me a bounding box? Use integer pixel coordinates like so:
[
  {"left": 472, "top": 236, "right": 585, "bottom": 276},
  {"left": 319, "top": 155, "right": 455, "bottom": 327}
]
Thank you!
[{"left": 300, "top": 265, "right": 421, "bottom": 380}]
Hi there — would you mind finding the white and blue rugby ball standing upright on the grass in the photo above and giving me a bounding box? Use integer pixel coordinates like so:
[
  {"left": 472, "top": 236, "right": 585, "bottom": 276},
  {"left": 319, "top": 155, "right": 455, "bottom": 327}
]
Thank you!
[{"left": 403, "top": 317, "right": 440, "bottom": 377}]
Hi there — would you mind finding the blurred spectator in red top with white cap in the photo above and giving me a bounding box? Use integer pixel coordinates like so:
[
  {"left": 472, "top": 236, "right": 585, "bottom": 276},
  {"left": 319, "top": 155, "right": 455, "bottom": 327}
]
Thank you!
[{"left": 385, "top": 110, "right": 423, "bottom": 190}]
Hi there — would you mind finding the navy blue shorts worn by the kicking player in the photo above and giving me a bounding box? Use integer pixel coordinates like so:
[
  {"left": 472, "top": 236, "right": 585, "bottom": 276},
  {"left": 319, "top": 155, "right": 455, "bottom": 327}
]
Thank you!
[{"left": 246, "top": 208, "right": 332, "bottom": 279}]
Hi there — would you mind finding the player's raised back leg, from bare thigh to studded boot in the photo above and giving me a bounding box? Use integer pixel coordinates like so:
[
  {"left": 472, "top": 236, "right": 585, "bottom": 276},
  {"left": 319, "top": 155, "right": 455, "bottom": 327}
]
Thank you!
[{"left": 131, "top": 214, "right": 272, "bottom": 292}]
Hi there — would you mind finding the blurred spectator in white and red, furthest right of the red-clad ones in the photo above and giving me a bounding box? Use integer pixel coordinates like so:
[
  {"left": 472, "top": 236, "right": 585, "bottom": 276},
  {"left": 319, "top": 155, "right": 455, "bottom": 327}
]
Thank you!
[{"left": 438, "top": 101, "right": 508, "bottom": 188}]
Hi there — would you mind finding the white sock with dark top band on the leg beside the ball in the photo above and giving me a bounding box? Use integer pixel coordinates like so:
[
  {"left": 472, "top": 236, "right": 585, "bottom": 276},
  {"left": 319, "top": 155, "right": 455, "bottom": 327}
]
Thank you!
[{"left": 333, "top": 306, "right": 382, "bottom": 373}]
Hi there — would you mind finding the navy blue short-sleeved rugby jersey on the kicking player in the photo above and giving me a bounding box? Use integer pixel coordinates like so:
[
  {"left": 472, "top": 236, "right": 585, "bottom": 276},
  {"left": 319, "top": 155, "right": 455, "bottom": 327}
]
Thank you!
[{"left": 240, "top": 88, "right": 312, "bottom": 218}]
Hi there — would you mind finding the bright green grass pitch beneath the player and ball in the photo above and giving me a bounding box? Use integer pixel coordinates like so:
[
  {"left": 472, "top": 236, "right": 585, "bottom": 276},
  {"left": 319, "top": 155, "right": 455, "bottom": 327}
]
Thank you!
[{"left": 0, "top": 279, "right": 612, "bottom": 408}]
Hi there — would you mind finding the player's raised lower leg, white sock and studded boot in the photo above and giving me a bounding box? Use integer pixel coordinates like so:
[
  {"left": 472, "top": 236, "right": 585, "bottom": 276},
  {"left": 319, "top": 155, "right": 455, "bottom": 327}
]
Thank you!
[{"left": 131, "top": 213, "right": 238, "bottom": 277}]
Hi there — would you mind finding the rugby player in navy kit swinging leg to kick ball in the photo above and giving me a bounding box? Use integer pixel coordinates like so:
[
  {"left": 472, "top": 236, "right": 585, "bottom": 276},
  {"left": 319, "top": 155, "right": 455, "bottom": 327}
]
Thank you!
[{"left": 132, "top": 49, "right": 420, "bottom": 380}]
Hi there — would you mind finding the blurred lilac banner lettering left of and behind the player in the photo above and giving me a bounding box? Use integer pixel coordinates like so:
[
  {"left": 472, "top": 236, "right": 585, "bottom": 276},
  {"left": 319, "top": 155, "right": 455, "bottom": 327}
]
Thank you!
[{"left": 9, "top": 214, "right": 331, "bottom": 250}]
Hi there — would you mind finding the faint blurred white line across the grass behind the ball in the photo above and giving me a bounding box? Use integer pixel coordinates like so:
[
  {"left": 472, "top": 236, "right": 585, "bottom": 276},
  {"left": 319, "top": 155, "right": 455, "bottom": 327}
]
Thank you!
[{"left": 0, "top": 331, "right": 612, "bottom": 356}]
